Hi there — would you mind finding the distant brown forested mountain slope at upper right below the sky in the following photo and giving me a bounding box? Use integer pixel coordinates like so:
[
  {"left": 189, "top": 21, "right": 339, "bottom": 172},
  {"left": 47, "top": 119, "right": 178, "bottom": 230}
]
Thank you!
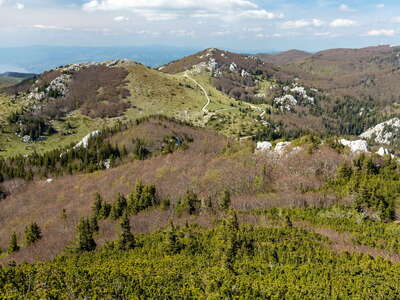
[{"left": 257, "top": 45, "right": 400, "bottom": 103}]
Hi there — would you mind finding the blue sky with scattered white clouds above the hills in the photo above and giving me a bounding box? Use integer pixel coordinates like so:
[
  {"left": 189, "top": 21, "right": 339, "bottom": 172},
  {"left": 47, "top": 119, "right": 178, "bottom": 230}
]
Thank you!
[{"left": 0, "top": 0, "right": 400, "bottom": 51}]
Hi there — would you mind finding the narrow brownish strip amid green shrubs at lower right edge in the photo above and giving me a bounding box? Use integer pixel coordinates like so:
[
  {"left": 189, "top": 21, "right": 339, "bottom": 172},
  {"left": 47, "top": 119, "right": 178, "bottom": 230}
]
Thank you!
[{"left": 293, "top": 221, "right": 400, "bottom": 262}]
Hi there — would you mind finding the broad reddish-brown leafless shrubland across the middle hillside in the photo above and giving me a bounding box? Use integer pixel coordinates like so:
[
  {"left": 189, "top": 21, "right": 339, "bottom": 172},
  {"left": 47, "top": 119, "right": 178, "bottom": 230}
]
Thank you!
[{"left": 0, "top": 120, "right": 345, "bottom": 261}]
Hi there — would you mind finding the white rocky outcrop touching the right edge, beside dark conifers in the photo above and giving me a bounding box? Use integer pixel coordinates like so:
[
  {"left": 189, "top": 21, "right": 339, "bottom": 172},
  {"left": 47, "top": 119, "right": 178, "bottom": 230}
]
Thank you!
[{"left": 360, "top": 118, "right": 400, "bottom": 145}]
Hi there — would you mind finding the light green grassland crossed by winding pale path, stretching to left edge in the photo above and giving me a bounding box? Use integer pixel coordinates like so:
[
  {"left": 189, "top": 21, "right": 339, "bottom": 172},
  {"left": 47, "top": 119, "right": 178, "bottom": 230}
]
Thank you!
[{"left": 0, "top": 64, "right": 268, "bottom": 156}]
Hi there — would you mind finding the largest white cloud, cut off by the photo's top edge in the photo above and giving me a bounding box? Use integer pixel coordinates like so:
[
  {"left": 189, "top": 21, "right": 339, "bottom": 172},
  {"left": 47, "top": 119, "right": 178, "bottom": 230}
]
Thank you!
[{"left": 82, "top": 0, "right": 283, "bottom": 20}]
